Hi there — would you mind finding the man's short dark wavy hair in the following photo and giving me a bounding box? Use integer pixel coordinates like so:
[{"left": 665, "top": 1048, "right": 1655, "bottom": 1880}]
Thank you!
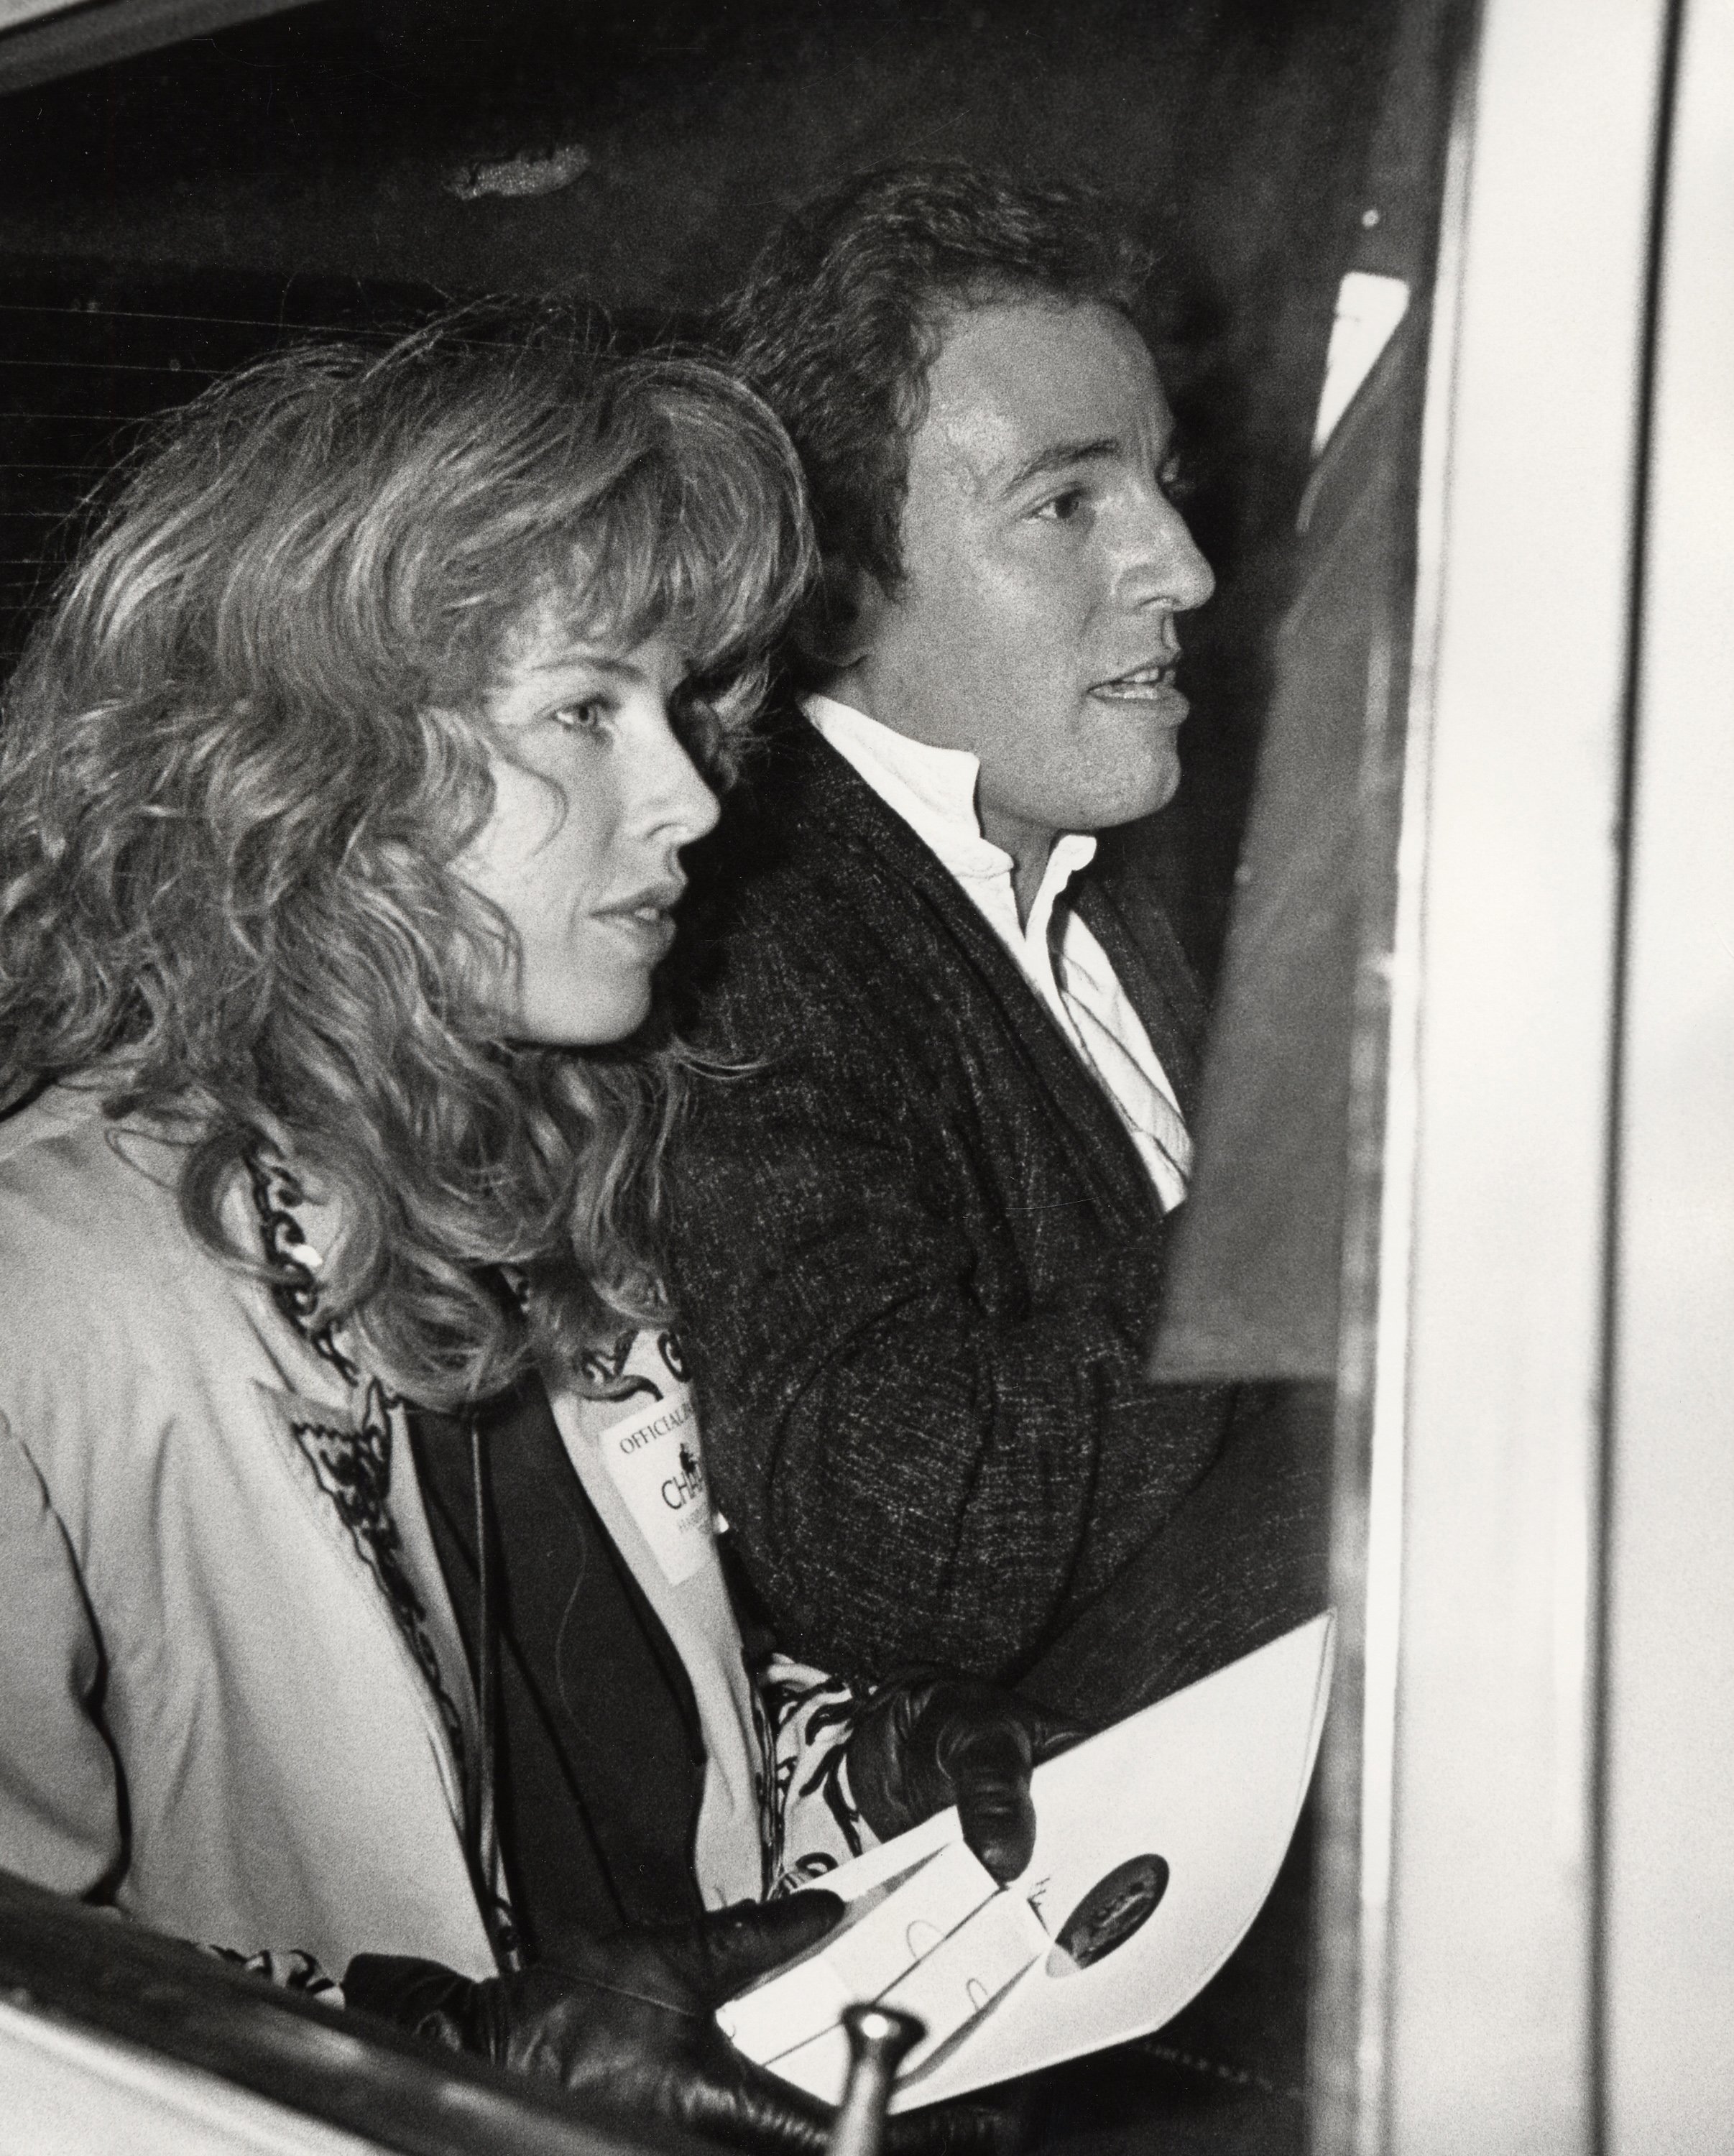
[{"left": 722, "top": 162, "right": 1152, "bottom": 606}]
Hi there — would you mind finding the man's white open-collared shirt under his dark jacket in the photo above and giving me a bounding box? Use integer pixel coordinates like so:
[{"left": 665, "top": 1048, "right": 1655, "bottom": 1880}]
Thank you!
[{"left": 804, "top": 696, "right": 1193, "bottom": 1212}]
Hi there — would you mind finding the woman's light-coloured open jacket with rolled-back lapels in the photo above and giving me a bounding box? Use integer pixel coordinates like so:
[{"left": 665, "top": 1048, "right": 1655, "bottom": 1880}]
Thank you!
[{"left": 0, "top": 1087, "right": 806, "bottom": 1975}]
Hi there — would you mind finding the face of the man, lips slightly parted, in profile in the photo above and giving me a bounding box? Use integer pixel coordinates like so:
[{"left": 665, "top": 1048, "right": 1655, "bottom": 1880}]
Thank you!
[{"left": 836, "top": 300, "right": 1214, "bottom": 865}]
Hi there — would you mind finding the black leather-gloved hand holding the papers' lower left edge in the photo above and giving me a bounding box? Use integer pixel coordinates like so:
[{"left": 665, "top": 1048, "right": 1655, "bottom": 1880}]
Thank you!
[{"left": 343, "top": 1891, "right": 1003, "bottom": 2156}]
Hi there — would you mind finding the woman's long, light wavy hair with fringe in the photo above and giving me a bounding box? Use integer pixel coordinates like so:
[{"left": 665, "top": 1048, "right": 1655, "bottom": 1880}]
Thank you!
[{"left": 0, "top": 310, "right": 811, "bottom": 1406}]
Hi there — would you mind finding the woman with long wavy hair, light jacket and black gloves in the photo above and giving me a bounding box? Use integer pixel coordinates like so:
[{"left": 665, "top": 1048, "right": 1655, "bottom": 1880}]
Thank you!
[{"left": 0, "top": 319, "right": 1029, "bottom": 2145}]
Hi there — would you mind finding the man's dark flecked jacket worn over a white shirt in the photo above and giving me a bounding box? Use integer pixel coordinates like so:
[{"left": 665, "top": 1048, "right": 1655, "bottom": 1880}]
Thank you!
[{"left": 670, "top": 718, "right": 1225, "bottom": 1677}]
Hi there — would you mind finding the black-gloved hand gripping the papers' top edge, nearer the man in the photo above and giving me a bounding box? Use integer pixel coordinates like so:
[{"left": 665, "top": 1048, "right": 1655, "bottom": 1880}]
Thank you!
[{"left": 845, "top": 1667, "right": 1087, "bottom": 1884}]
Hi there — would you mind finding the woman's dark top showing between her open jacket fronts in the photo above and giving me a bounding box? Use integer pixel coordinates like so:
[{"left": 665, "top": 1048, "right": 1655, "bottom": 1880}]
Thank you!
[{"left": 410, "top": 1380, "right": 705, "bottom": 1953}]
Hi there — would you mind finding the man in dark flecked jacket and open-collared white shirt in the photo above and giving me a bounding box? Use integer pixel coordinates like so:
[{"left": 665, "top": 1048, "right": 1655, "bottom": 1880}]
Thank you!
[{"left": 673, "top": 166, "right": 1320, "bottom": 1718}]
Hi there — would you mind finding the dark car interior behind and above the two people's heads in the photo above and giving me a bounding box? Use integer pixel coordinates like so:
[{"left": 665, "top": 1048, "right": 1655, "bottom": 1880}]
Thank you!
[{"left": 0, "top": 0, "right": 1396, "bottom": 962}]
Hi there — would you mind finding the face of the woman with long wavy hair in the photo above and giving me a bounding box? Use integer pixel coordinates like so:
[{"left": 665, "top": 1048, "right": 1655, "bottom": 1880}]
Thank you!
[{"left": 453, "top": 606, "right": 716, "bottom": 1048}]
